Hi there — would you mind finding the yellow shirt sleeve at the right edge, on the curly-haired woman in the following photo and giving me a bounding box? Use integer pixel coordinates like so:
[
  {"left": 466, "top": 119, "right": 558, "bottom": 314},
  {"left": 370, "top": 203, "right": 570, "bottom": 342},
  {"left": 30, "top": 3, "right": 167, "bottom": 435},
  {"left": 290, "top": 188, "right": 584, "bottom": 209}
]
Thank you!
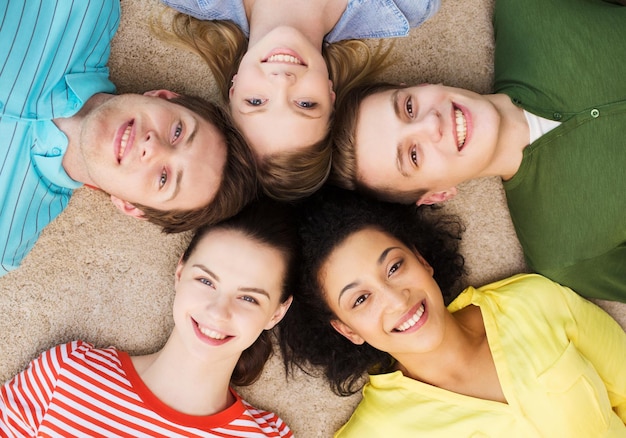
[{"left": 561, "top": 287, "right": 626, "bottom": 424}]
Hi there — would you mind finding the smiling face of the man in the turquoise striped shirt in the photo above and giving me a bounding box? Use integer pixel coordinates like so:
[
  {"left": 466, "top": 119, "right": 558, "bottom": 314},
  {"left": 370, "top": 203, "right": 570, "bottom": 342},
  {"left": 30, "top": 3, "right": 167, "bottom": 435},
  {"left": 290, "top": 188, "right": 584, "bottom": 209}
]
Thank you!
[{"left": 80, "top": 94, "right": 226, "bottom": 210}]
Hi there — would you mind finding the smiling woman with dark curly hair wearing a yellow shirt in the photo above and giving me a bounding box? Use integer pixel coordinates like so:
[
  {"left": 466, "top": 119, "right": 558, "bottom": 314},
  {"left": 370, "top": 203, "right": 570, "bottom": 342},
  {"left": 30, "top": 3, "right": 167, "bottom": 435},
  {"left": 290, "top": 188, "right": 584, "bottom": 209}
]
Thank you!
[{"left": 282, "top": 186, "right": 626, "bottom": 438}]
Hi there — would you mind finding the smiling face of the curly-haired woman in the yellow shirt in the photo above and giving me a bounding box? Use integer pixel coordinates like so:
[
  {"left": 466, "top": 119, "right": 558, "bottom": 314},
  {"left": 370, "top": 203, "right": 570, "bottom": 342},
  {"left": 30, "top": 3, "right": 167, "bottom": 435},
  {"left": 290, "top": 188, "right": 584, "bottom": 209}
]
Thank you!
[{"left": 319, "top": 228, "right": 450, "bottom": 362}]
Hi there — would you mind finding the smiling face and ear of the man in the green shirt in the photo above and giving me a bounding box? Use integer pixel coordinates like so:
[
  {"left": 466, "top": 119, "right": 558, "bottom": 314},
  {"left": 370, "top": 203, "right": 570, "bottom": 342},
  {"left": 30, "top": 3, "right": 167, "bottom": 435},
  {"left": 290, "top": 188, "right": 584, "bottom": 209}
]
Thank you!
[{"left": 355, "top": 85, "right": 500, "bottom": 203}]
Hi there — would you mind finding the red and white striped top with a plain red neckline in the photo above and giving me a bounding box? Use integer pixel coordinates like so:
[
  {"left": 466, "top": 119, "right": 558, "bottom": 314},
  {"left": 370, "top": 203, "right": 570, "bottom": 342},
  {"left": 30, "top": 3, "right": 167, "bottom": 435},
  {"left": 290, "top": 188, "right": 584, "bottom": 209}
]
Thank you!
[{"left": 0, "top": 341, "right": 292, "bottom": 438}]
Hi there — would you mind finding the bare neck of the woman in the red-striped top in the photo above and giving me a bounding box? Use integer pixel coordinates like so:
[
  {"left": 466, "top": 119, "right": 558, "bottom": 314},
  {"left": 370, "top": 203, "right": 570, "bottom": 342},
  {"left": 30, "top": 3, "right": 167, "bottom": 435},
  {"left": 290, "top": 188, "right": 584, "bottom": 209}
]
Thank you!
[{"left": 132, "top": 329, "right": 238, "bottom": 416}]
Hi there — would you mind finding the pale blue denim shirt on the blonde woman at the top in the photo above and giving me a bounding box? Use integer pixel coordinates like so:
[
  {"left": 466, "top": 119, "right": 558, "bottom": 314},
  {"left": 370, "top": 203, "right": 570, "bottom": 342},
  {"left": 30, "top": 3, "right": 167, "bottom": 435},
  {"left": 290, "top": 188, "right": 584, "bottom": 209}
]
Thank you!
[{"left": 162, "top": 0, "right": 441, "bottom": 43}]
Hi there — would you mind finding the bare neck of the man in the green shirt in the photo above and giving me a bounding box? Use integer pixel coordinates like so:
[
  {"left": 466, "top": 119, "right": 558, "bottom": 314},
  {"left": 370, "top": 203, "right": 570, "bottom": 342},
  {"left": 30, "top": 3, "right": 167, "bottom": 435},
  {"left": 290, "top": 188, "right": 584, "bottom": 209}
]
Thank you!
[{"left": 485, "top": 94, "right": 530, "bottom": 181}]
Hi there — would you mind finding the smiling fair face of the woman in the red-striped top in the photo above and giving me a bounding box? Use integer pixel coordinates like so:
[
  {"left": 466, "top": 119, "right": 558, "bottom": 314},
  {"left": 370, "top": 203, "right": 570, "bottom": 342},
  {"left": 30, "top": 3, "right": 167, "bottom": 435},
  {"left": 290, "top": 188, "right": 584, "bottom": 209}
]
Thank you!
[{"left": 173, "top": 228, "right": 291, "bottom": 360}]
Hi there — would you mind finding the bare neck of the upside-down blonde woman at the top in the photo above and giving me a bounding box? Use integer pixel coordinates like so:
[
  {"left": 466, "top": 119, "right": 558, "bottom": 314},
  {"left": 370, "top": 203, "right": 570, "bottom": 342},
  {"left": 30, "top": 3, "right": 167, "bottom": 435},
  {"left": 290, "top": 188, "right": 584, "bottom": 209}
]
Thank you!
[{"left": 244, "top": 0, "right": 347, "bottom": 50}]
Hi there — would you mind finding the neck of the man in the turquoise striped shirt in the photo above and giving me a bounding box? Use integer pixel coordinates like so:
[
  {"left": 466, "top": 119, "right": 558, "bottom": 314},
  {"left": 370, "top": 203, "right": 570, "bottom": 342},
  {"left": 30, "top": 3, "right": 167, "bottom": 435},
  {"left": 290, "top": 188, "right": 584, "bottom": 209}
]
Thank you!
[{"left": 58, "top": 93, "right": 113, "bottom": 185}]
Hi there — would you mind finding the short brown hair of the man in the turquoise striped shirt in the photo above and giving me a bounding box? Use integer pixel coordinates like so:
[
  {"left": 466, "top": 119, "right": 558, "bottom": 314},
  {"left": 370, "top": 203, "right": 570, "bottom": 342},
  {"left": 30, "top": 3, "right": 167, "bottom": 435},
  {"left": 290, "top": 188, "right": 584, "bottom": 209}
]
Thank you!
[{"left": 135, "top": 95, "right": 259, "bottom": 233}]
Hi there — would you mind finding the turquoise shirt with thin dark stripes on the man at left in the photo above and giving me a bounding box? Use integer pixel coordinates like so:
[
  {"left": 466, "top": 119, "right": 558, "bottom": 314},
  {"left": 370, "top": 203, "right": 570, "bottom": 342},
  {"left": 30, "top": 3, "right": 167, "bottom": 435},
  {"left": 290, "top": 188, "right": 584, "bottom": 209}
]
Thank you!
[{"left": 0, "top": 0, "right": 120, "bottom": 276}]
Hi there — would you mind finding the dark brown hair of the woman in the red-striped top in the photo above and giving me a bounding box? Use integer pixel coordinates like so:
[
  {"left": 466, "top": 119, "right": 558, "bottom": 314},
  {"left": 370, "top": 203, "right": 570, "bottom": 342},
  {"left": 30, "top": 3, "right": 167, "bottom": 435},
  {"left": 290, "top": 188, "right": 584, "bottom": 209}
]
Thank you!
[{"left": 181, "top": 199, "right": 299, "bottom": 386}]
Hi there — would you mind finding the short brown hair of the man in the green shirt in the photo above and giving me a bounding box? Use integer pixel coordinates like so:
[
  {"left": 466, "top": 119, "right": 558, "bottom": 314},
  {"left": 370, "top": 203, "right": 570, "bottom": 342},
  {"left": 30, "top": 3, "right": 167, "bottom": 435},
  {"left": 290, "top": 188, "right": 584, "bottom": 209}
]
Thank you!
[{"left": 329, "top": 82, "right": 416, "bottom": 204}]
